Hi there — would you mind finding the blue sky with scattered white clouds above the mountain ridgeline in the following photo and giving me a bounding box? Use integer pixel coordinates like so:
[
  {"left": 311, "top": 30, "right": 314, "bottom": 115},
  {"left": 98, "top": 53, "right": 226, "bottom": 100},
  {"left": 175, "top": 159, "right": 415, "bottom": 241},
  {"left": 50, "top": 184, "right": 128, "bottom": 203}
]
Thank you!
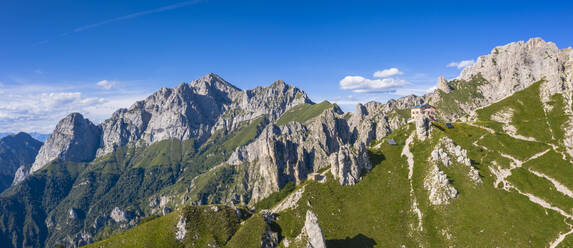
[{"left": 0, "top": 0, "right": 573, "bottom": 132}]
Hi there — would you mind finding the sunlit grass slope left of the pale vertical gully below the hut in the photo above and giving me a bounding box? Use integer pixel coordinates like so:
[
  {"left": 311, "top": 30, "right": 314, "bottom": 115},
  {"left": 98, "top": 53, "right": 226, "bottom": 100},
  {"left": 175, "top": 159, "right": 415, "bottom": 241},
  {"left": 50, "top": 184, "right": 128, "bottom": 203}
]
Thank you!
[{"left": 277, "top": 127, "right": 416, "bottom": 247}]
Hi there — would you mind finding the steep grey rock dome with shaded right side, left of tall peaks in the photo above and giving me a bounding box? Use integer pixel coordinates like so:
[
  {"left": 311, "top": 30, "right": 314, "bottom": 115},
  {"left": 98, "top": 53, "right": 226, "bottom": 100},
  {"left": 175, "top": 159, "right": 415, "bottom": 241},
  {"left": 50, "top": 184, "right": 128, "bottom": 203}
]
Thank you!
[{"left": 30, "top": 113, "right": 101, "bottom": 173}]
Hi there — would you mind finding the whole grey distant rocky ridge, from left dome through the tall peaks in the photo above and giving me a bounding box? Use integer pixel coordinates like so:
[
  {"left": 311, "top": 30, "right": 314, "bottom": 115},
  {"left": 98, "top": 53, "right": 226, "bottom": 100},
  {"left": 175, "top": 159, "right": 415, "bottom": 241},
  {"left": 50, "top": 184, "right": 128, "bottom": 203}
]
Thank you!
[{"left": 31, "top": 73, "right": 313, "bottom": 172}]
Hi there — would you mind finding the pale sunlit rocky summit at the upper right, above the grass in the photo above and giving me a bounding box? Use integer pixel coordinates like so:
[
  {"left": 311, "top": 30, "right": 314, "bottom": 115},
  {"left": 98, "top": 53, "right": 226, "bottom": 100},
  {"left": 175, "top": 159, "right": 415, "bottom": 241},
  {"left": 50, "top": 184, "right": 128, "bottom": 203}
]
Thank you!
[{"left": 454, "top": 38, "right": 573, "bottom": 155}]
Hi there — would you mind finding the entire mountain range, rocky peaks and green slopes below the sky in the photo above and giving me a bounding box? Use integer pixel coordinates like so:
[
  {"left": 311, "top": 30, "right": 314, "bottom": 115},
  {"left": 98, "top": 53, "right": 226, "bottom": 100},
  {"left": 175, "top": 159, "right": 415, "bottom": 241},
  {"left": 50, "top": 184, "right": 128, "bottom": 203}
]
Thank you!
[{"left": 0, "top": 38, "right": 573, "bottom": 247}]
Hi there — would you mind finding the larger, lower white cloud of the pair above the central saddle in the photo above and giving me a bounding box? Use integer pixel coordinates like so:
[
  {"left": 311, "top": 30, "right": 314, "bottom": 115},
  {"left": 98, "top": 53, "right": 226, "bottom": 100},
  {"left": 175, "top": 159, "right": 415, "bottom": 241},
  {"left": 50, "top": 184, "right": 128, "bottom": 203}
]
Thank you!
[{"left": 340, "top": 76, "right": 408, "bottom": 93}]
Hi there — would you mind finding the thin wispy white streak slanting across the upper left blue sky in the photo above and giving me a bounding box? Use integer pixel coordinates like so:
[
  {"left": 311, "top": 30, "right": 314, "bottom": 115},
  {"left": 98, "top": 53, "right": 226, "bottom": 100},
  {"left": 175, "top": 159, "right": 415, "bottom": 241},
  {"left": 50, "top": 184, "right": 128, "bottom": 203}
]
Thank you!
[{"left": 34, "top": 0, "right": 207, "bottom": 46}]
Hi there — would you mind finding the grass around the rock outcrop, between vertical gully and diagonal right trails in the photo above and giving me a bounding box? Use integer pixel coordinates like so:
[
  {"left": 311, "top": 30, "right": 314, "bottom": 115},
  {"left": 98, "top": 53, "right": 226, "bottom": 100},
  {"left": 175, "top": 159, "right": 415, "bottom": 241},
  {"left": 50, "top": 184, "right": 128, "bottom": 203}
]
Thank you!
[{"left": 406, "top": 125, "right": 567, "bottom": 247}]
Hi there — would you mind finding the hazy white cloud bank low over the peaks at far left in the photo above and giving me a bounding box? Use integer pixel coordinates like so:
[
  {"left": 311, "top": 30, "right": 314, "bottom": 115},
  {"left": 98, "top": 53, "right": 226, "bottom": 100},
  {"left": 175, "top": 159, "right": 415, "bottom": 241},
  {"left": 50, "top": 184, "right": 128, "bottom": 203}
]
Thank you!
[{"left": 0, "top": 84, "right": 148, "bottom": 133}]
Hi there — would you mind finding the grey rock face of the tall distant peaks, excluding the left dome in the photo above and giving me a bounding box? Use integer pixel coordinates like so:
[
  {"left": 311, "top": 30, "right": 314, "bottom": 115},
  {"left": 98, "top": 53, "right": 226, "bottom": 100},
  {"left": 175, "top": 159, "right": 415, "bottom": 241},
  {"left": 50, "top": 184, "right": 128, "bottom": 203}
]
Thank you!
[{"left": 97, "top": 73, "right": 312, "bottom": 156}]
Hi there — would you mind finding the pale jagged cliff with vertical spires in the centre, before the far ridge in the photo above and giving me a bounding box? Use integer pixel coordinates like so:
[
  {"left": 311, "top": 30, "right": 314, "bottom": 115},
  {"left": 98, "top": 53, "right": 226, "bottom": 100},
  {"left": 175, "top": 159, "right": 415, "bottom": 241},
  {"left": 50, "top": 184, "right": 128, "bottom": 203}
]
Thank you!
[{"left": 228, "top": 108, "right": 371, "bottom": 201}]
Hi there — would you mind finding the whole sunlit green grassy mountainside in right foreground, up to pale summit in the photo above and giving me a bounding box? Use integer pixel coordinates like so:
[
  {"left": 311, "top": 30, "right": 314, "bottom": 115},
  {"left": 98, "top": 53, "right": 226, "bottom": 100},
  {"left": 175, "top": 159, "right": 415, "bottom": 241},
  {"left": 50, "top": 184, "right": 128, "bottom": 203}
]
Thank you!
[{"left": 85, "top": 81, "right": 573, "bottom": 247}]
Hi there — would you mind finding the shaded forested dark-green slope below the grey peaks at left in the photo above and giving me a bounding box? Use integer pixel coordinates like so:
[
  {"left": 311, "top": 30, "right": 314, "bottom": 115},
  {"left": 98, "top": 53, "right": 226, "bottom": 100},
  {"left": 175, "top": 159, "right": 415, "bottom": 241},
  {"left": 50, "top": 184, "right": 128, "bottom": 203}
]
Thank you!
[{"left": 0, "top": 116, "right": 266, "bottom": 246}]
